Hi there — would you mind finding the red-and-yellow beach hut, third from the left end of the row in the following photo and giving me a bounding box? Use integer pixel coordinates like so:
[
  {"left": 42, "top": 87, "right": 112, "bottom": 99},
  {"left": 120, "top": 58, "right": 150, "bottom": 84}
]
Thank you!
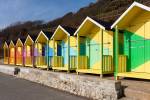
[{"left": 16, "top": 37, "right": 25, "bottom": 66}]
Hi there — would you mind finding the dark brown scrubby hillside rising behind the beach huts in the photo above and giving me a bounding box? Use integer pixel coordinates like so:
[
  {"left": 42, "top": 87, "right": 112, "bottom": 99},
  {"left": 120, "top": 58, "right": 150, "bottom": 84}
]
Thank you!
[{"left": 0, "top": 0, "right": 150, "bottom": 56}]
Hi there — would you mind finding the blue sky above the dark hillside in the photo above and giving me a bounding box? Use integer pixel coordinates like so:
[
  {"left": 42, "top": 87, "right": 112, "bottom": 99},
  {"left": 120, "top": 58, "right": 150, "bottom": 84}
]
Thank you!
[{"left": 0, "top": 0, "right": 96, "bottom": 28}]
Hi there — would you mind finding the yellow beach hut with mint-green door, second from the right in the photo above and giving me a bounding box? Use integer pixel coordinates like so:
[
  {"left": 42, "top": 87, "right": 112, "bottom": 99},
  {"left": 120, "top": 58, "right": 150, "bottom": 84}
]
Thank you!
[{"left": 74, "top": 17, "right": 114, "bottom": 76}]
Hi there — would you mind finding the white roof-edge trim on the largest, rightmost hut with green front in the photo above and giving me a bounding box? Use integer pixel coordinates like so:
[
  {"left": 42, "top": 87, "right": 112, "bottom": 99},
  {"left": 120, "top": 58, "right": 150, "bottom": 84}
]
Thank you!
[{"left": 111, "top": 2, "right": 150, "bottom": 29}]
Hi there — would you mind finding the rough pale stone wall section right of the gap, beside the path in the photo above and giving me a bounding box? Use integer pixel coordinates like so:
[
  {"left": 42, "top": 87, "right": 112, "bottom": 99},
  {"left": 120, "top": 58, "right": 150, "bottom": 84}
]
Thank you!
[{"left": 0, "top": 66, "right": 122, "bottom": 100}]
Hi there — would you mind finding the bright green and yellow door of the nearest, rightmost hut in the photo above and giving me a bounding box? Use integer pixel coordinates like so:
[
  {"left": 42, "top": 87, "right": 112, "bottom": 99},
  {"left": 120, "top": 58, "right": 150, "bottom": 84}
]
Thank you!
[{"left": 124, "top": 26, "right": 145, "bottom": 72}]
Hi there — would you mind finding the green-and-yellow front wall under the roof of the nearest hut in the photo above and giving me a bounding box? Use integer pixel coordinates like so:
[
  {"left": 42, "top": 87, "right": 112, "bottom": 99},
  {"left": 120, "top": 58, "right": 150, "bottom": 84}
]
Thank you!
[{"left": 123, "top": 12, "right": 150, "bottom": 73}]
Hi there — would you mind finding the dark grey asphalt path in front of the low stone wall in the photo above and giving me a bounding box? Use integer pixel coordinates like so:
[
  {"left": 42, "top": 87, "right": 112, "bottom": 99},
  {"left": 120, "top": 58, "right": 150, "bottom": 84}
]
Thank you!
[{"left": 0, "top": 73, "right": 87, "bottom": 100}]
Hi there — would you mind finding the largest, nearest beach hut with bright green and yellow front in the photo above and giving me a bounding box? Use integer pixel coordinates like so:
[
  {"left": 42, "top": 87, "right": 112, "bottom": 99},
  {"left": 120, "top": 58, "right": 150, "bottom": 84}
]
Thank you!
[{"left": 111, "top": 2, "right": 150, "bottom": 79}]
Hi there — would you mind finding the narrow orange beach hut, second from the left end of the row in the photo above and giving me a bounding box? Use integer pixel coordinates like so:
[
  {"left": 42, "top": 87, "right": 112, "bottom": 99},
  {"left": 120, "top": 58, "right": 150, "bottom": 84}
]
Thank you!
[{"left": 9, "top": 40, "right": 16, "bottom": 65}]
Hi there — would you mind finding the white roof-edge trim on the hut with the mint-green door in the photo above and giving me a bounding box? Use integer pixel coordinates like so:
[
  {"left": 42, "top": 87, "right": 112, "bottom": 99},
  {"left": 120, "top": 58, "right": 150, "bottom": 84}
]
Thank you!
[{"left": 74, "top": 16, "right": 105, "bottom": 35}]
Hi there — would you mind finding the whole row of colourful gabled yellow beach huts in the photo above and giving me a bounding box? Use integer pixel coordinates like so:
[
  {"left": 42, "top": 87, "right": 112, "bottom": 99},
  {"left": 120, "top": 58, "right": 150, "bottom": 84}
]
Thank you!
[{"left": 4, "top": 2, "right": 150, "bottom": 79}]
